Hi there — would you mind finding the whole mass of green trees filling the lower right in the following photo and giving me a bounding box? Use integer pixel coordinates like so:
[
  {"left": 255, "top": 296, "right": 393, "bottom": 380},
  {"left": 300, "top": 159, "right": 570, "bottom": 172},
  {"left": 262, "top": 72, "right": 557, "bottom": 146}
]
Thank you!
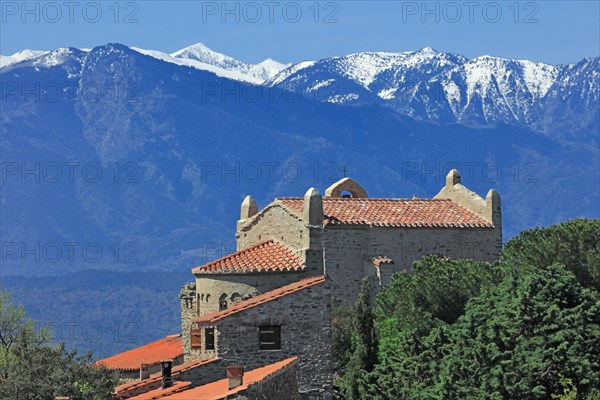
[{"left": 334, "top": 220, "right": 600, "bottom": 400}]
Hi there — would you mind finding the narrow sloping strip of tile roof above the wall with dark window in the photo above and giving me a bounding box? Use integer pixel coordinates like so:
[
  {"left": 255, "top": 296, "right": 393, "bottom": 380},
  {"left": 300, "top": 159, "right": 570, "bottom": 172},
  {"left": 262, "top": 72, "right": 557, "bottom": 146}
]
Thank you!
[{"left": 194, "top": 275, "right": 325, "bottom": 323}]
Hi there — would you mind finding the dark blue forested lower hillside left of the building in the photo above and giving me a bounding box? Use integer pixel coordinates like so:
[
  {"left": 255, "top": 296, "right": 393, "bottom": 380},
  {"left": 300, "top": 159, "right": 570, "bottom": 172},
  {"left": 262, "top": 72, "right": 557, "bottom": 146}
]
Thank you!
[{"left": 0, "top": 270, "right": 194, "bottom": 359}]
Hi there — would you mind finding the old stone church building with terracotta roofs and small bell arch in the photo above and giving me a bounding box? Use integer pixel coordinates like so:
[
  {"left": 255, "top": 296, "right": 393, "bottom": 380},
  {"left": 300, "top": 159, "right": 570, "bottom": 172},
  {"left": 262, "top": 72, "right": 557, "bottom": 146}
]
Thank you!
[{"left": 99, "top": 170, "right": 502, "bottom": 399}]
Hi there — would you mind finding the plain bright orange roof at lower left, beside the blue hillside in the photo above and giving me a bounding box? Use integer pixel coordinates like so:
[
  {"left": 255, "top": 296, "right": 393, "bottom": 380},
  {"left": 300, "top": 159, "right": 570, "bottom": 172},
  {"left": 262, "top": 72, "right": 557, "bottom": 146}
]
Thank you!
[{"left": 96, "top": 334, "right": 183, "bottom": 371}]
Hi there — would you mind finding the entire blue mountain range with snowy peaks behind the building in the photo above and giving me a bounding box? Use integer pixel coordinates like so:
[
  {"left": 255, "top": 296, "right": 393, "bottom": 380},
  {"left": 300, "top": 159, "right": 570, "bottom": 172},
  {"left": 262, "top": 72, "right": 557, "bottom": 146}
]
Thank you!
[{"left": 0, "top": 44, "right": 600, "bottom": 275}]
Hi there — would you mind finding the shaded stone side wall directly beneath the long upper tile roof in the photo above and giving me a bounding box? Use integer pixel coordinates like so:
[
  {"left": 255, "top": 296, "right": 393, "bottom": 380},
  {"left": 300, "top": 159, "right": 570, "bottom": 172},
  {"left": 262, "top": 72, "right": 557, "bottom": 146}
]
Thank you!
[{"left": 323, "top": 226, "right": 502, "bottom": 305}]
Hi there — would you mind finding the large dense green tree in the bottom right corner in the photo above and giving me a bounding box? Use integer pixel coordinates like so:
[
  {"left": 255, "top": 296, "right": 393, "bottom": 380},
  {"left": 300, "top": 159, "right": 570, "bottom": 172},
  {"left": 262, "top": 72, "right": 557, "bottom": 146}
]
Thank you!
[{"left": 435, "top": 265, "right": 600, "bottom": 400}]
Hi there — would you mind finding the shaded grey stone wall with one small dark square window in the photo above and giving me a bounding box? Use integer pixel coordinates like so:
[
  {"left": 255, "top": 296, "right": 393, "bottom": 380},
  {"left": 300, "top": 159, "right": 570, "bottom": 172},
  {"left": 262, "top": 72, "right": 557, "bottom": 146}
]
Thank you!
[{"left": 200, "top": 281, "right": 333, "bottom": 392}]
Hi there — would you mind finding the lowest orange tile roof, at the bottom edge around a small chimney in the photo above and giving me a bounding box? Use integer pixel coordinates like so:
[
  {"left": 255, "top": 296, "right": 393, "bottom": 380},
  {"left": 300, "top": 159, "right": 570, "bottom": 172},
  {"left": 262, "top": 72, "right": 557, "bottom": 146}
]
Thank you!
[{"left": 161, "top": 357, "right": 298, "bottom": 400}]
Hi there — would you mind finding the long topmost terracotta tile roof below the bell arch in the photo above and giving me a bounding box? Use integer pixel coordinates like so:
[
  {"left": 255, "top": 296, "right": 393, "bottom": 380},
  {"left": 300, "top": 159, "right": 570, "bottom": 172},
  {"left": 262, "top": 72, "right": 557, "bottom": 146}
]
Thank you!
[{"left": 275, "top": 197, "right": 494, "bottom": 228}]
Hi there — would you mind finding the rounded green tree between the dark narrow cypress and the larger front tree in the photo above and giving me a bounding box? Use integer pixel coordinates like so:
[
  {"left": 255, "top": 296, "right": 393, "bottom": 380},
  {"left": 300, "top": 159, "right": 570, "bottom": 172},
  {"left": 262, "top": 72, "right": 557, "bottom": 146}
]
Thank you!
[{"left": 365, "top": 256, "right": 500, "bottom": 399}]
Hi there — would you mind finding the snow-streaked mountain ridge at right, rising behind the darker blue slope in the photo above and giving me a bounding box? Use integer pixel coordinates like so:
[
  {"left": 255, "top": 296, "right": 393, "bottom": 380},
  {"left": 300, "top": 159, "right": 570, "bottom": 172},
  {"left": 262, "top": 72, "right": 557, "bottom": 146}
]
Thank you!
[{"left": 265, "top": 48, "right": 600, "bottom": 140}]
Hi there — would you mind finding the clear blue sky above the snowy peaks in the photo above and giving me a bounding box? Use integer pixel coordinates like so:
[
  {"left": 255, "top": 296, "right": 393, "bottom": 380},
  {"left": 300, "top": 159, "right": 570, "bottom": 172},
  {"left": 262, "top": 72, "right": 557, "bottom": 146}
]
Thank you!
[{"left": 0, "top": 0, "right": 600, "bottom": 64}]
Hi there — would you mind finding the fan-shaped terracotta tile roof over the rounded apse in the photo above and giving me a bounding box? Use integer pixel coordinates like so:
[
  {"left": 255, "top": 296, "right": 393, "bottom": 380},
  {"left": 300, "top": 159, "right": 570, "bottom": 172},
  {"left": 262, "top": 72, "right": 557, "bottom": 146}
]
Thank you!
[{"left": 192, "top": 240, "right": 305, "bottom": 273}]
